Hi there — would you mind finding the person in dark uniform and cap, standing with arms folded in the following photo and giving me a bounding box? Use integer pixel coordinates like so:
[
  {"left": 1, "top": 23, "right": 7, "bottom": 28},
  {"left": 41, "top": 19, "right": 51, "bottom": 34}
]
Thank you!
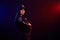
[{"left": 16, "top": 5, "right": 32, "bottom": 40}]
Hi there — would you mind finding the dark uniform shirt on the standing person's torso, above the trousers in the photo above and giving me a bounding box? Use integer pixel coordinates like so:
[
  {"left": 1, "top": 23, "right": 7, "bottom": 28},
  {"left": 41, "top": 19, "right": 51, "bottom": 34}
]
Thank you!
[{"left": 16, "top": 17, "right": 29, "bottom": 32}]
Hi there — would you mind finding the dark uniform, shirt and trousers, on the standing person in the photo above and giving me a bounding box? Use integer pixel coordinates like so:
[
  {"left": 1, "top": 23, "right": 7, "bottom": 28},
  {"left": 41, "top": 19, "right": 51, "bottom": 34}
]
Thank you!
[{"left": 16, "top": 17, "right": 32, "bottom": 40}]
